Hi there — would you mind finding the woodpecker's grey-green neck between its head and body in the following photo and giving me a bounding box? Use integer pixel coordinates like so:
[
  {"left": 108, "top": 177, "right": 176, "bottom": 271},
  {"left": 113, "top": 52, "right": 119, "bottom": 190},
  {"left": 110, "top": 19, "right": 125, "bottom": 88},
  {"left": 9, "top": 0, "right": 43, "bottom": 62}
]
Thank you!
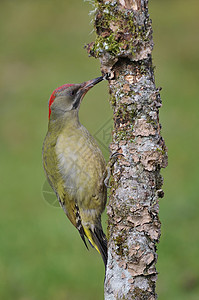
[{"left": 48, "top": 109, "right": 81, "bottom": 132}]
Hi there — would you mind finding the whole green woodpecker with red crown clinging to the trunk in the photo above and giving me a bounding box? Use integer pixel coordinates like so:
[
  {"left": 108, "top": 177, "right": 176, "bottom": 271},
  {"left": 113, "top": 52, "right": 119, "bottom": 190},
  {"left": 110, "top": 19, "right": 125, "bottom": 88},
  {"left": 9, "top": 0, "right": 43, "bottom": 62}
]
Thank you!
[{"left": 43, "top": 77, "right": 107, "bottom": 266}]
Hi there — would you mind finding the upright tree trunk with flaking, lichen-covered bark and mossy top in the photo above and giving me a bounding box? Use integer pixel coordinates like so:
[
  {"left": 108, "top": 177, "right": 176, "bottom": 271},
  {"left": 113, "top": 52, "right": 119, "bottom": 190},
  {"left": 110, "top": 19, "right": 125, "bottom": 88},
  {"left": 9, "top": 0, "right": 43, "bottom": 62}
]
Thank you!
[{"left": 88, "top": 0, "right": 167, "bottom": 300}]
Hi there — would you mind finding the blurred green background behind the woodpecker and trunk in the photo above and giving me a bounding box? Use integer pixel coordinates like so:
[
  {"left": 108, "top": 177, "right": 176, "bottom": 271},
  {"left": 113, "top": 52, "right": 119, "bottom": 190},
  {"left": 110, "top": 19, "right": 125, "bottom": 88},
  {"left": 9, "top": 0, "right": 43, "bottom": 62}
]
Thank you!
[{"left": 0, "top": 0, "right": 199, "bottom": 300}]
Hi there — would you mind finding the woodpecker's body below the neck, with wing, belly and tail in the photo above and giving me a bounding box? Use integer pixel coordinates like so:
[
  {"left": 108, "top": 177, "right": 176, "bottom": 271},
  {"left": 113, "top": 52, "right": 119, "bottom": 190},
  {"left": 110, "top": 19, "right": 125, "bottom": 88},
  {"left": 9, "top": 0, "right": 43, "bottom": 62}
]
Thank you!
[{"left": 43, "top": 126, "right": 107, "bottom": 264}]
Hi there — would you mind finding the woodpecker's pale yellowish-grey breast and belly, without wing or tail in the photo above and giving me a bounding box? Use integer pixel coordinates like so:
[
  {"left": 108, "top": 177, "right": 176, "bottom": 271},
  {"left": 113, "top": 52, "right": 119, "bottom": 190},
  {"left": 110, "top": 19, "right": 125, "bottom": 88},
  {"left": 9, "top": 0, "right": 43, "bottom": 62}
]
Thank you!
[{"left": 55, "top": 126, "right": 106, "bottom": 202}]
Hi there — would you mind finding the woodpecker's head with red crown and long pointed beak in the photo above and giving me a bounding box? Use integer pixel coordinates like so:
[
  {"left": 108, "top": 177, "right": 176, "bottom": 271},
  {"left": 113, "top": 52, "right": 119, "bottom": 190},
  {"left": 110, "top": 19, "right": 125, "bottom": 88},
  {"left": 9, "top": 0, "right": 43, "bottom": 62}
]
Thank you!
[{"left": 48, "top": 76, "right": 104, "bottom": 119}]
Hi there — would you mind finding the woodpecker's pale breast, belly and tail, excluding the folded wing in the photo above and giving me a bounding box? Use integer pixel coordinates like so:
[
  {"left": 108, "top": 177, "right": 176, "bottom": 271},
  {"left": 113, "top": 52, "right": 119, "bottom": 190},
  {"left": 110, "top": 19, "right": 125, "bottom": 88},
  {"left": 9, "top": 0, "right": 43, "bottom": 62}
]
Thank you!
[{"left": 56, "top": 126, "right": 107, "bottom": 263}]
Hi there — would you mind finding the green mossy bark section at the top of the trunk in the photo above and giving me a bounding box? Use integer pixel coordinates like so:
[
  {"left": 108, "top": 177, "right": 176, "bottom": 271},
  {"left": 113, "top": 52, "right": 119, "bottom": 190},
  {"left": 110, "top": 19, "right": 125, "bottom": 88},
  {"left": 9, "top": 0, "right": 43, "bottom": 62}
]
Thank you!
[{"left": 89, "top": 1, "right": 151, "bottom": 57}]
